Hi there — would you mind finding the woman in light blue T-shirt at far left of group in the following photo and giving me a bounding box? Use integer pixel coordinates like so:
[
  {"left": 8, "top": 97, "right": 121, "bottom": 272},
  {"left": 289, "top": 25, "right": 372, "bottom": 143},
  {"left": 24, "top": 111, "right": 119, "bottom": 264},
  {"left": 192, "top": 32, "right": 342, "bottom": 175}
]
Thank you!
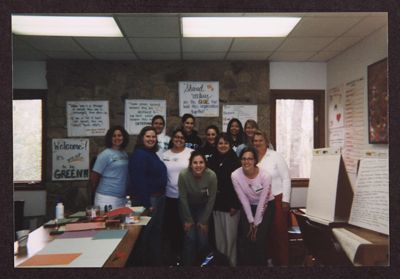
[{"left": 90, "top": 126, "right": 129, "bottom": 208}]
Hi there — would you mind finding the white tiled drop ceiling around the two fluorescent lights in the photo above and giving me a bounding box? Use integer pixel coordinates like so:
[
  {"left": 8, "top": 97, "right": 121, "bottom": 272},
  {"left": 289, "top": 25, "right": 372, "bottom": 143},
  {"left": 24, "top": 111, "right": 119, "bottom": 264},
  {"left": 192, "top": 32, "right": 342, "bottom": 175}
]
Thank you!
[{"left": 13, "top": 13, "right": 388, "bottom": 62}]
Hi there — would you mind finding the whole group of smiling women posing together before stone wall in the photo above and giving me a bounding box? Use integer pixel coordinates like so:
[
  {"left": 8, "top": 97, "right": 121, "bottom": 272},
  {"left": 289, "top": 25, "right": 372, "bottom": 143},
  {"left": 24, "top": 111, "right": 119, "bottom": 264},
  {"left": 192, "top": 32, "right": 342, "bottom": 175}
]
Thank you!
[{"left": 91, "top": 114, "right": 290, "bottom": 266}]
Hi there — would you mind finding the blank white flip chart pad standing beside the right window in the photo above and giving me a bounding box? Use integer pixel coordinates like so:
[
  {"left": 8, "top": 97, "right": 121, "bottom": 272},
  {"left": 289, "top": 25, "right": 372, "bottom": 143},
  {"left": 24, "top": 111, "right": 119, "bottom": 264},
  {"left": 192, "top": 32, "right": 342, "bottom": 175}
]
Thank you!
[{"left": 306, "top": 148, "right": 341, "bottom": 222}]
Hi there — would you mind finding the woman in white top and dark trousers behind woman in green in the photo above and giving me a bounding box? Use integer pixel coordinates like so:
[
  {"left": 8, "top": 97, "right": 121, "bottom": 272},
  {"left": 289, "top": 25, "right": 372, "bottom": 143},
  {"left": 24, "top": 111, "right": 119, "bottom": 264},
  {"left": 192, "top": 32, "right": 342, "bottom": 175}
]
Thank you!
[{"left": 161, "top": 129, "right": 193, "bottom": 265}]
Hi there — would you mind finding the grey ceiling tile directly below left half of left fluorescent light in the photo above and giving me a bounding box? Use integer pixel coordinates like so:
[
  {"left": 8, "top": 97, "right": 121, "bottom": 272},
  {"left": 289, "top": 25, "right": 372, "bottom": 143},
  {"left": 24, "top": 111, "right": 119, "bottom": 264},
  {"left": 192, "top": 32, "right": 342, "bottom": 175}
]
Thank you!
[{"left": 20, "top": 36, "right": 81, "bottom": 51}]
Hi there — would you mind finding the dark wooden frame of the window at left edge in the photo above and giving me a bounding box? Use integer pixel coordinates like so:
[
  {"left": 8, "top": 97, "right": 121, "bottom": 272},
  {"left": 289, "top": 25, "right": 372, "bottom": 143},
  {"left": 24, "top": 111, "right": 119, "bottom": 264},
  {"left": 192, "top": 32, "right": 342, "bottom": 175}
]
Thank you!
[{"left": 13, "top": 89, "right": 47, "bottom": 191}]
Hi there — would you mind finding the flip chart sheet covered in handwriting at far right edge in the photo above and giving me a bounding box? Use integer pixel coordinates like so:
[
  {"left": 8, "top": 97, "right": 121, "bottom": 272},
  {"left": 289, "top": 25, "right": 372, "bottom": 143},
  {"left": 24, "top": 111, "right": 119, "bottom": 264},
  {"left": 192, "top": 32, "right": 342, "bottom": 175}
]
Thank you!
[{"left": 349, "top": 158, "right": 389, "bottom": 235}]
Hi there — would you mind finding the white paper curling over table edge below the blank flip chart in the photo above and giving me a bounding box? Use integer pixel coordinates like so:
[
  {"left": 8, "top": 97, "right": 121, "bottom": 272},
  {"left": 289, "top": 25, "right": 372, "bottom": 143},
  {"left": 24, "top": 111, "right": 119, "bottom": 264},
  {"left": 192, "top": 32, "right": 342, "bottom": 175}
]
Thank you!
[{"left": 332, "top": 228, "right": 371, "bottom": 263}]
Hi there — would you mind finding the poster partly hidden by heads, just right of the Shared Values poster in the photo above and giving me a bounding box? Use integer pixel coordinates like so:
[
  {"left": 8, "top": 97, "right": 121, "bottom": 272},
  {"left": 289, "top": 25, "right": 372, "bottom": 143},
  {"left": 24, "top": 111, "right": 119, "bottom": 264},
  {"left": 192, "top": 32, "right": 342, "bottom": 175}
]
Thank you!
[{"left": 222, "top": 105, "right": 257, "bottom": 131}]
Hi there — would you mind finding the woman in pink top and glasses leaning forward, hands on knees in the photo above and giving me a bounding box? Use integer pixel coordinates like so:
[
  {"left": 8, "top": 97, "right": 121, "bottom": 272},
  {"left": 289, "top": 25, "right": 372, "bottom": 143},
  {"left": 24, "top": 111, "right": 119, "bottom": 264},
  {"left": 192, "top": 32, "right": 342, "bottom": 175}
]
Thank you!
[{"left": 231, "top": 147, "right": 274, "bottom": 265}]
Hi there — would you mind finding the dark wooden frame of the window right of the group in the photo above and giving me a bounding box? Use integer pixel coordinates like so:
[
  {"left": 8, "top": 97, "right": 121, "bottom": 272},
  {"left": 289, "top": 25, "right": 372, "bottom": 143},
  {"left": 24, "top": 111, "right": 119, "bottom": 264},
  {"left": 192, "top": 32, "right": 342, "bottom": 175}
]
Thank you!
[{"left": 270, "top": 90, "right": 325, "bottom": 187}]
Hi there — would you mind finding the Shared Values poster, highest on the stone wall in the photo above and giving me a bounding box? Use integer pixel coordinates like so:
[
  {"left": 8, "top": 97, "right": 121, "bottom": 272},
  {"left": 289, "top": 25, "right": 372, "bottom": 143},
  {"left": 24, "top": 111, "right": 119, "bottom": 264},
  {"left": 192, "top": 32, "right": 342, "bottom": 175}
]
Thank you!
[{"left": 179, "top": 81, "right": 219, "bottom": 117}]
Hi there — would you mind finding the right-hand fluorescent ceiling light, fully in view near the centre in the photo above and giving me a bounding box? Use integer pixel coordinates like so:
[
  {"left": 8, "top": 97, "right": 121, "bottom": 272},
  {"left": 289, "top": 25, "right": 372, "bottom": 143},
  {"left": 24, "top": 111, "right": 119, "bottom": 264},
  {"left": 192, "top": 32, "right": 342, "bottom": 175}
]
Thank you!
[{"left": 182, "top": 17, "right": 301, "bottom": 37}]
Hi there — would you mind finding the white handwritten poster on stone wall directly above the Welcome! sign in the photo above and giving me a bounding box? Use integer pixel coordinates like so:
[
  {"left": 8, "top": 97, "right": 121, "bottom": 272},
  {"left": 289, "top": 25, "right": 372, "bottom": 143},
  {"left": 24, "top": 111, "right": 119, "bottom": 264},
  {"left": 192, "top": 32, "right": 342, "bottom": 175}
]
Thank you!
[{"left": 67, "top": 101, "right": 110, "bottom": 137}]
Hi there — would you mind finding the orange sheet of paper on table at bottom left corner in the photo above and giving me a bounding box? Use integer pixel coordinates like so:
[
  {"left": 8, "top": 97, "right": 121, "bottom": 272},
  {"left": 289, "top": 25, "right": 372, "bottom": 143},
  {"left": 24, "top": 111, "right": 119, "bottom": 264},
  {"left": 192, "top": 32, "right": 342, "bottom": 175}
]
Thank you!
[{"left": 18, "top": 253, "right": 82, "bottom": 267}]
